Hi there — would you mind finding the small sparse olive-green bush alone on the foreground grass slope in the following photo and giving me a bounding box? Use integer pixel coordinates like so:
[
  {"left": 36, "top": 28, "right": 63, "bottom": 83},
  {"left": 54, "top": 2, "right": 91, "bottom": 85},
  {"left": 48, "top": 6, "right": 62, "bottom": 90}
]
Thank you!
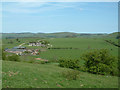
[{"left": 62, "top": 70, "right": 80, "bottom": 80}]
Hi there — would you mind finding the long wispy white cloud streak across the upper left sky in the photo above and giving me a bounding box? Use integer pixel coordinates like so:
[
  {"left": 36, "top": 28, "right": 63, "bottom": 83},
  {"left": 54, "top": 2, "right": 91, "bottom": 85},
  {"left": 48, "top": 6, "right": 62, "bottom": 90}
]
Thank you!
[{"left": 3, "top": 2, "right": 83, "bottom": 13}]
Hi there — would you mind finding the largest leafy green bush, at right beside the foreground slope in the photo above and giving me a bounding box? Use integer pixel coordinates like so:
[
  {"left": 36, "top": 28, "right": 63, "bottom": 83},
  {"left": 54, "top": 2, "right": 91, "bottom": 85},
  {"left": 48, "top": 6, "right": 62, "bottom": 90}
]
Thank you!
[{"left": 82, "top": 49, "right": 118, "bottom": 75}]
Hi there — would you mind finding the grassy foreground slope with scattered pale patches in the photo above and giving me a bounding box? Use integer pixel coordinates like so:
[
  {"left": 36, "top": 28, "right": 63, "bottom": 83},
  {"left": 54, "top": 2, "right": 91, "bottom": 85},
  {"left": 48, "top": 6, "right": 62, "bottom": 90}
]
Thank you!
[{"left": 2, "top": 61, "right": 118, "bottom": 88}]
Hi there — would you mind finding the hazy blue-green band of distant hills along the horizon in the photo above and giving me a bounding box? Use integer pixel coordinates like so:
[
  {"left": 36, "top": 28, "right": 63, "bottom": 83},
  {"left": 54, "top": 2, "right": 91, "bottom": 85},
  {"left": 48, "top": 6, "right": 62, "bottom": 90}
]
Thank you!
[{"left": 2, "top": 32, "right": 107, "bottom": 38}]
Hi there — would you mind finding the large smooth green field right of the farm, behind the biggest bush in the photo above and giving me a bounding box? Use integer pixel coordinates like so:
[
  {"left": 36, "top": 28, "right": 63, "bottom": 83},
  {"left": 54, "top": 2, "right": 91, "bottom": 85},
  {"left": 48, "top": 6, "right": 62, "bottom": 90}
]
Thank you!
[{"left": 40, "top": 38, "right": 118, "bottom": 60}]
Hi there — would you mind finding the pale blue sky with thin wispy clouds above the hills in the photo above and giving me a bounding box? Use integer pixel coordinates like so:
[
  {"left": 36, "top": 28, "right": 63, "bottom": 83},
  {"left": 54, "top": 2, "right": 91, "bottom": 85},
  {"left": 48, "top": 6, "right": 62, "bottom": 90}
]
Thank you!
[{"left": 2, "top": 2, "right": 118, "bottom": 33}]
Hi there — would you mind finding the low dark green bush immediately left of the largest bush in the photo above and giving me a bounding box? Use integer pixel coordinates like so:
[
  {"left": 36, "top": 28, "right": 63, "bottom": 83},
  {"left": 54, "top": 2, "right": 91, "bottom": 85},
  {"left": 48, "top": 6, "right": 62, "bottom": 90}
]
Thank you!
[{"left": 59, "top": 59, "right": 79, "bottom": 69}]
